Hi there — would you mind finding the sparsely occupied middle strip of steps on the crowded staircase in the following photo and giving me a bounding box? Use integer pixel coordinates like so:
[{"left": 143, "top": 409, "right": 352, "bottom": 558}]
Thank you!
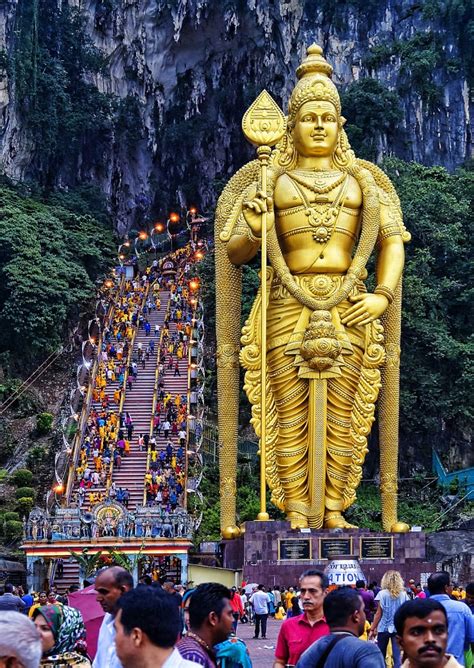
[{"left": 112, "top": 291, "right": 169, "bottom": 510}]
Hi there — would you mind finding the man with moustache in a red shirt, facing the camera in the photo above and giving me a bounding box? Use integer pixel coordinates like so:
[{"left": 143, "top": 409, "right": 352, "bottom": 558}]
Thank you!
[{"left": 273, "top": 570, "right": 329, "bottom": 668}]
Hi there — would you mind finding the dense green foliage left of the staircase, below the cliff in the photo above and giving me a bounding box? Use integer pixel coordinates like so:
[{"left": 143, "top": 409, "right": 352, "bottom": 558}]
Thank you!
[{"left": 0, "top": 180, "right": 113, "bottom": 367}]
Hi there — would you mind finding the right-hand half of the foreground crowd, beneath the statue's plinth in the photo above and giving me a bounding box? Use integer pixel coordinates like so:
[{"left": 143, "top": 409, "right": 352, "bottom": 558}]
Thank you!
[{"left": 241, "top": 570, "right": 474, "bottom": 668}]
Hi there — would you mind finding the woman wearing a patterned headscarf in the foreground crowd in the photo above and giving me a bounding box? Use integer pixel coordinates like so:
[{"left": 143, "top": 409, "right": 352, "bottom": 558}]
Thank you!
[{"left": 33, "top": 605, "right": 91, "bottom": 668}]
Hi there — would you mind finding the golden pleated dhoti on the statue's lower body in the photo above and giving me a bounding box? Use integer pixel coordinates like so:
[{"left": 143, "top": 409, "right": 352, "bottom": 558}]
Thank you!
[{"left": 241, "top": 272, "right": 384, "bottom": 528}]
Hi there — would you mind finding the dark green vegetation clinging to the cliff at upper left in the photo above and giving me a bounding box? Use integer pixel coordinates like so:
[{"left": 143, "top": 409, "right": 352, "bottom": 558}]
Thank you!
[{"left": 10, "top": 0, "right": 113, "bottom": 188}]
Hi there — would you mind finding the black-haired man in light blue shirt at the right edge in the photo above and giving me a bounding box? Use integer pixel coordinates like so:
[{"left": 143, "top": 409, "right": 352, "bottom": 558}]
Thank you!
[{"left": 428, "top": 571, "right": 474, "bottom": 666}]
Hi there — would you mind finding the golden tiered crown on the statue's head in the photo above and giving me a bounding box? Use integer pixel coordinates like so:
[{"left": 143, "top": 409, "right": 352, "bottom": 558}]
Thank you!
[{"left": 288, "top": 44, "right": 341, "bottom": 125}]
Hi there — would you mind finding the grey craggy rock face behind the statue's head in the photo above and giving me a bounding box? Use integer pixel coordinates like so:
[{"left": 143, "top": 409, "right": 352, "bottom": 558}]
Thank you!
[{"left": 0, "top": 0, "right": 470, "bottom": 232}]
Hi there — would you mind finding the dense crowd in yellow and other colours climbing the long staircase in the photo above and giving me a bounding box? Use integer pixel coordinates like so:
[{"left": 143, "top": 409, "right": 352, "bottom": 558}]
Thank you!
[{"left": 69, "top": 241, "right": 196, "bottom": 512}]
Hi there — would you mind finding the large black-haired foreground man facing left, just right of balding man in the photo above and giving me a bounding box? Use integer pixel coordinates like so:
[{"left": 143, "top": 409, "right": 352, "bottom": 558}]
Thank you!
[{"left": 114, "top": 586, "right": 199, "bottom": 668}]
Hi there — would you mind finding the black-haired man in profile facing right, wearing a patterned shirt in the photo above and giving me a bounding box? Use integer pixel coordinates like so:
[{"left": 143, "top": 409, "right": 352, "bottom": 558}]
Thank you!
[{"left": 177, "top": 582, "right": 234, "bottom": 668}]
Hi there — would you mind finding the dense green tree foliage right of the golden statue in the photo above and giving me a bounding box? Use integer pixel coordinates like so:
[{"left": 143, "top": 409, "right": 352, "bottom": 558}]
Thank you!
[{"left": 384, "top": 159, "right": 474, "bottom": 465}]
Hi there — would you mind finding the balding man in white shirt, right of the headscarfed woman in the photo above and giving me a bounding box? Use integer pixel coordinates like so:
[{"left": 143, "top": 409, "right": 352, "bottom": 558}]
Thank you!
[{"left": 92, "top": 566, "right": 133, "bottom": 668}]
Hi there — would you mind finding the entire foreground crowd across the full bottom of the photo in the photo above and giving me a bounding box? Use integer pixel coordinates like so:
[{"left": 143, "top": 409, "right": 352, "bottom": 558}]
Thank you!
[{"left": 0, "top": 566, "right": 474, "bottom": 668}]
